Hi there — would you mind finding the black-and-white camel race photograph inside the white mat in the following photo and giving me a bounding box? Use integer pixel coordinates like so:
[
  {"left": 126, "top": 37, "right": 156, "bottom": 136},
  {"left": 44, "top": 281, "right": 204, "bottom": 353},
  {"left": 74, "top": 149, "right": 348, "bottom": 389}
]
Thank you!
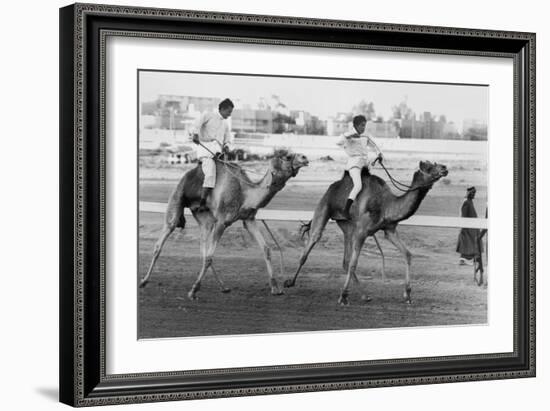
[{"left": 136, "top": 68, "right": 491, "bottom": 339}]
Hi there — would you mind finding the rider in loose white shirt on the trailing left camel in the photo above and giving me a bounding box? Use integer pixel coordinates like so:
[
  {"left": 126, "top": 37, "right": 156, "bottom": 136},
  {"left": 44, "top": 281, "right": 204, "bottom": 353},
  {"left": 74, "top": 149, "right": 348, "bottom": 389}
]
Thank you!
[{"left": 193, "top": 98, "right": 234, "bottom": 211}]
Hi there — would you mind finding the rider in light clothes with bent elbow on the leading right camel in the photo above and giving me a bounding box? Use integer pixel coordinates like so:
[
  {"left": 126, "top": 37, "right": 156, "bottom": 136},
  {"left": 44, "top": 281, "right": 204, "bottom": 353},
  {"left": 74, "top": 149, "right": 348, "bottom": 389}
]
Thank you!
[{"left": 337, "top": 115, "right": 383, "bottom": 220}]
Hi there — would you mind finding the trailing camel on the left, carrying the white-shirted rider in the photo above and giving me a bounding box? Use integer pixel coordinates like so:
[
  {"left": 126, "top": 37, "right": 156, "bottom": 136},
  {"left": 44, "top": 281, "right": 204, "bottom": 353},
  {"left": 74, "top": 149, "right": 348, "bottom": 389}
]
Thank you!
[{"left": 140, "top": 150, "right": 308, "bottom": 300}]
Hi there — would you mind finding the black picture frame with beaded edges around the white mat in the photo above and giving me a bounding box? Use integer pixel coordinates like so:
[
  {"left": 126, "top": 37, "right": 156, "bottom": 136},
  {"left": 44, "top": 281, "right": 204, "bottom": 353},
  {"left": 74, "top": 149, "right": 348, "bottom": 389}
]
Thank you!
[{"left": 60, "top": 4, "right": 535, "bottom": 406}]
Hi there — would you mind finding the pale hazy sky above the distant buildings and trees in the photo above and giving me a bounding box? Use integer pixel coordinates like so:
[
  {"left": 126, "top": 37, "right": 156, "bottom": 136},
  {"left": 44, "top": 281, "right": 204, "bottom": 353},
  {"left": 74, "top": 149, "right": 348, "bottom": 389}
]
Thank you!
[{"left": 140, "top": 71, "right": 488, "bottom": 125}]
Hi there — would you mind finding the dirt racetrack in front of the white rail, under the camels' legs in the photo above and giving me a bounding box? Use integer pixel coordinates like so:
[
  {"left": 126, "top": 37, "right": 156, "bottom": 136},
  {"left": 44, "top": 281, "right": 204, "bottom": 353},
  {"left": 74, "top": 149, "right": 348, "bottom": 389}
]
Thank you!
[{"left": 138, "top": 213, "right": 487, "bottom": 338}]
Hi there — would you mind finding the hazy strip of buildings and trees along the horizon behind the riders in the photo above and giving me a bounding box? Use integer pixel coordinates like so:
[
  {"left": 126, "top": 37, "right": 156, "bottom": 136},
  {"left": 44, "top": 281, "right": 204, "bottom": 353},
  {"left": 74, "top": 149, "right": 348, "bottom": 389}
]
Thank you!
[{"left": 140, "top": 94, "right": 487, "bottom": 148}]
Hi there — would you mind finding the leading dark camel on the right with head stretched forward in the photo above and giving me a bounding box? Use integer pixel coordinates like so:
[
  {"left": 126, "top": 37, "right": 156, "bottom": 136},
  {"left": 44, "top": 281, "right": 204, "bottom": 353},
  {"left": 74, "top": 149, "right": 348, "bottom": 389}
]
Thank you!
[{"left": 284, "top": 161, "right": 448, "bottom": 305}]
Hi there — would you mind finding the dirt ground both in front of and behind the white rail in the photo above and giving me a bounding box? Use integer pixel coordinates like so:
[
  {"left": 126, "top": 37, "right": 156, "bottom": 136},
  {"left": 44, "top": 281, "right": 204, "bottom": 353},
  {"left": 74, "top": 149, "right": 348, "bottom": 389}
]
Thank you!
[{"left": 136, "top": 156, "right": 487, "bottom": 338}]
